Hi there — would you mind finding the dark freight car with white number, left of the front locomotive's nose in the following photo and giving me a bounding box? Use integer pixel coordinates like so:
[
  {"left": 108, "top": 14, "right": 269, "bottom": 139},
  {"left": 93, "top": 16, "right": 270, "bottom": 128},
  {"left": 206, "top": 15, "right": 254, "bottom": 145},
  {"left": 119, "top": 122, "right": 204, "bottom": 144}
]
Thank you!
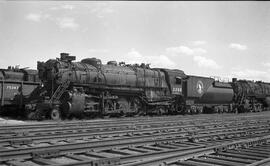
[{"left": 0, "top": 66, "right": 40, "bottom": 114}]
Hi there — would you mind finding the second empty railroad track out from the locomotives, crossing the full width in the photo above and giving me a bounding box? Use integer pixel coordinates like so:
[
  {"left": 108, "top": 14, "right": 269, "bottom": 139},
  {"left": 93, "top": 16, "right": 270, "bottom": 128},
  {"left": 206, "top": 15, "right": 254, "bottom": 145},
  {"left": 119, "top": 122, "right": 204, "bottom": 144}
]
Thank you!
[{"left": 0, "top": 114, "right": 269, "bottom": 148}]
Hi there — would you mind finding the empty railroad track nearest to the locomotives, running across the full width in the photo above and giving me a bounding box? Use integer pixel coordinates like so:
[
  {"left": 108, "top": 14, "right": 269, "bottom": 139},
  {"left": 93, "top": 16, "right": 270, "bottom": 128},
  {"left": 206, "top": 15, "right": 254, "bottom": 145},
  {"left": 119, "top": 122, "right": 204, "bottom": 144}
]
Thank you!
[{"left": 0, "top": 113, "right": 266, "bottom": 133}]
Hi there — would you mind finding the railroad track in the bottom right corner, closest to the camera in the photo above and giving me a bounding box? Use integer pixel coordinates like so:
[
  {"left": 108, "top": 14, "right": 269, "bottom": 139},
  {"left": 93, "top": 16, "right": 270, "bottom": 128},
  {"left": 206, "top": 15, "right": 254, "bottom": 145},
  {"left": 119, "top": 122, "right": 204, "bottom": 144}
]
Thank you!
[{"left": 123, "top": 135, "right": 270, "bottom": 166}]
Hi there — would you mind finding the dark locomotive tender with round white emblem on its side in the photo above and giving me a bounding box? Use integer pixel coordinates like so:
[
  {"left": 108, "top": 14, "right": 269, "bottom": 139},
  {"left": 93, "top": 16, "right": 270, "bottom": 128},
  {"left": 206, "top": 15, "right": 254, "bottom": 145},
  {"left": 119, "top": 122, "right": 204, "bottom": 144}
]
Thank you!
[{"left": 183, "top": 76, "right": 234, "bottom": 113}]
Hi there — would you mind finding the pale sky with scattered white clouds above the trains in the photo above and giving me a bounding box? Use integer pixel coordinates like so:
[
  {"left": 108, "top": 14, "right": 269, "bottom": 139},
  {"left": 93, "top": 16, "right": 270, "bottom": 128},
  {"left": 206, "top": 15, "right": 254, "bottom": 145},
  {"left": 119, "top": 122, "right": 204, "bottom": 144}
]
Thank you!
[{"left": 0, "top": 1, "right": 270, "bottom": 81}]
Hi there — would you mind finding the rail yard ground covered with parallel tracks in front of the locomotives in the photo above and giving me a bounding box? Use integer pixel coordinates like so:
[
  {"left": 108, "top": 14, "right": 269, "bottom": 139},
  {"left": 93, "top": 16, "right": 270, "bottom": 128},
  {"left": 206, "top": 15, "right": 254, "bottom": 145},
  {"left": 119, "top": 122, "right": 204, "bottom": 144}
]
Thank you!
[{"left": 0, "top": 111, "right": 270, "bottom": 166}]
